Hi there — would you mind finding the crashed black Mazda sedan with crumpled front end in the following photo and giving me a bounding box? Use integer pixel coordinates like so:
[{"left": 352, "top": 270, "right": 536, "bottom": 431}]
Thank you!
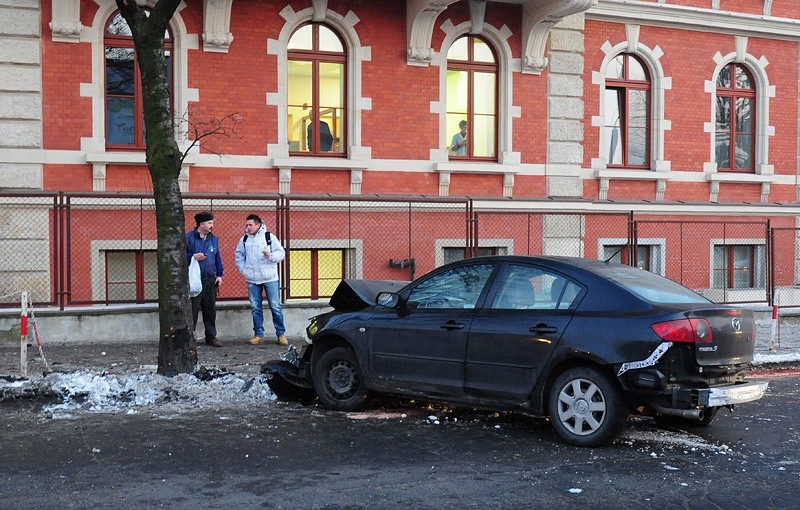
[{"left": 262, "top": 256, "right": 767, "bottom": 446}]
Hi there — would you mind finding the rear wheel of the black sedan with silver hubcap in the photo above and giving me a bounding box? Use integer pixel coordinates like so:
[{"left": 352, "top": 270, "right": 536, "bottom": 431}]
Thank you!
[{"left": 548, "top": 367, "right": 628, "bottom": 447}]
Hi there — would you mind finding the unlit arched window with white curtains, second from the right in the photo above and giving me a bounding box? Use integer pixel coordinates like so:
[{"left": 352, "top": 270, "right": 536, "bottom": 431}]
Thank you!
[{"left": 603, "top": 53, "right": 650, "bottom": 168}]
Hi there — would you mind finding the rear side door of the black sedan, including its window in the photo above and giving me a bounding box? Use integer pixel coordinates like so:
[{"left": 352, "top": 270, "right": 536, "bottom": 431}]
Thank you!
[{"left": 465, "top": 263, "right": 582, "bottom": 403}]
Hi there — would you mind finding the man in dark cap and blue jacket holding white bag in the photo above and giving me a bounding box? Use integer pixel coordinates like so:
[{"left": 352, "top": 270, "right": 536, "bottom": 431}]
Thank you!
[{"left": 186, "top": 211, "right": 223, "bottom": 347}]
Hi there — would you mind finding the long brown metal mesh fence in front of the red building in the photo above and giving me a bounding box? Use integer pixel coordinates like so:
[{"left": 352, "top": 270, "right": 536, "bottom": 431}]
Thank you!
[{"left": 0, "top": 192, "right": 800, "bottom": 309}]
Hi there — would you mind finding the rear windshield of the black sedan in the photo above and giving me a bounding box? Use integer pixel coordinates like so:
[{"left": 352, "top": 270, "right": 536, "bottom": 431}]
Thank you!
[{"left": 597, "top": 264, "right": 711, "bottom": 304}]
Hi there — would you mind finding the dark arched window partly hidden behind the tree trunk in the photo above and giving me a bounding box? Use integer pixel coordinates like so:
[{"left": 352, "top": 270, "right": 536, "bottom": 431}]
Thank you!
[{"left": 103, "top": 12, "right": 173, "bottom": 149}]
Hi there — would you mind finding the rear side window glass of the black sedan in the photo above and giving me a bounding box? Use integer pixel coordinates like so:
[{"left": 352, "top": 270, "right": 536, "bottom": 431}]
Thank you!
[{"left": 492, "top": 265, "right": 581, "bottom": 310}]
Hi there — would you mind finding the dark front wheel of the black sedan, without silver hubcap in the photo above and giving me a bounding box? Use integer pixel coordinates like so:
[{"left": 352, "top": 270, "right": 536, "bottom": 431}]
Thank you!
[{"left": 313, "top": 347, "right": 367, "bottom": 411}]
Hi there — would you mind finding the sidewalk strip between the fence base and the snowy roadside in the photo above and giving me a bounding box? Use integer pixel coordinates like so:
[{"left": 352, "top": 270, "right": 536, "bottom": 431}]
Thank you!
[{"left": 0, "top": 317, "right": 800, "bottom": 378}]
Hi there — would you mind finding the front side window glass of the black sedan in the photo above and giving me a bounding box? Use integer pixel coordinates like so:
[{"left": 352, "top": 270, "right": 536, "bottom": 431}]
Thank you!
[{"left": 406, "top": 264, "right": 494, "bottom": 308}]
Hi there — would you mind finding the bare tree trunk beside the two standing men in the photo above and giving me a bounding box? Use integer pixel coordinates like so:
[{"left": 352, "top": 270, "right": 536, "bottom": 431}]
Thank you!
[{"left": 116, "top": 0, "right": 197, "bottom": 375}]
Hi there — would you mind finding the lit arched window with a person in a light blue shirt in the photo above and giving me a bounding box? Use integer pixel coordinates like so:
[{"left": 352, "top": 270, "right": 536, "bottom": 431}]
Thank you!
[{"left": 446, "top": 35, "right": 497, "bottom": 160}]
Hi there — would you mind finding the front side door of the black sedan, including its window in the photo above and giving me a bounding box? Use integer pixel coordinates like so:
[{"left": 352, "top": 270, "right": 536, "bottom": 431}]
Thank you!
[{"left": 367, "top": 262, "right": 496, "bottom": 395}]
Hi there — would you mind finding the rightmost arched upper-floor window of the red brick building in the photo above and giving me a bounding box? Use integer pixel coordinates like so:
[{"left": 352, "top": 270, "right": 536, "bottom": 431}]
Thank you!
[{"left": 714, "top": 63, "right": 756, "bottom": 172}]
